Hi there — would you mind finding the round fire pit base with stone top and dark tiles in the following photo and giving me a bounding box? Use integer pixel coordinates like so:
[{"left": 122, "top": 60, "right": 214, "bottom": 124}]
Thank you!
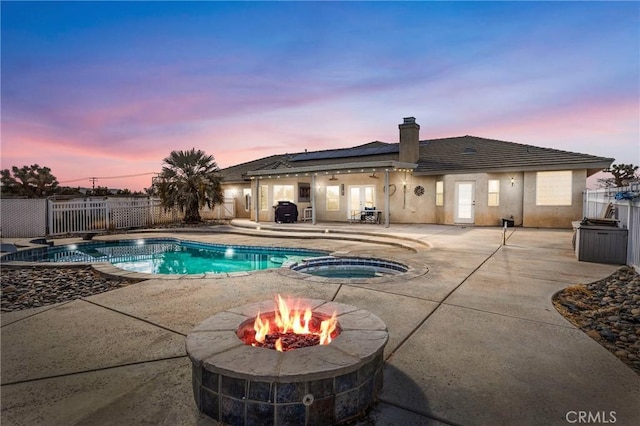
[{"left": 186, "top": 299, "right": 389, "bottom": 425}]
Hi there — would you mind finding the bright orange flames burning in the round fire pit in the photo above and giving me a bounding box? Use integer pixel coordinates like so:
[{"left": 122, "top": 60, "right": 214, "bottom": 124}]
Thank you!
[{"left": 245, "top": 295, "right": 338, "bottom": 352}]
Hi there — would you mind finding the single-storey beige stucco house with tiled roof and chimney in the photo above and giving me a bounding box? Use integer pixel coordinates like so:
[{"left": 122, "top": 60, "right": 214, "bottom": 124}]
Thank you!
[{"left": 221, "top": 117, "right": 614, "bottom": 228}]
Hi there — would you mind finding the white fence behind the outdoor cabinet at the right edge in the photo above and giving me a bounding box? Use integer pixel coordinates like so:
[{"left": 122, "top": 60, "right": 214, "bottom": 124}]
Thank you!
[{"left": 582, "top": 184, "right": 640, "bottom": 270}]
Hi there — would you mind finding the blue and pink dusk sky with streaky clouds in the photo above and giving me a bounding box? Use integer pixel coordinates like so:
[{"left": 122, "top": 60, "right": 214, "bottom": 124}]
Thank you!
[{"left": 0, "top": 1, "right": 640, "bottom": 190}]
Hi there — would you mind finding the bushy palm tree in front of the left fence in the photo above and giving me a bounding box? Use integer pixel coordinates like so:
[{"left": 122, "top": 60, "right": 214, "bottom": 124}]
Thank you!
[{"left": 156, "top": 148, "right": 223, "bottom": 223}]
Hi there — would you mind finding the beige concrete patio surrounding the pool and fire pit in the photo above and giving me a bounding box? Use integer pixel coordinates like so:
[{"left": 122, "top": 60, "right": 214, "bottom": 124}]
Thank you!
[{"left": 1, "top": 221, "right": 640, "bottom": 425}]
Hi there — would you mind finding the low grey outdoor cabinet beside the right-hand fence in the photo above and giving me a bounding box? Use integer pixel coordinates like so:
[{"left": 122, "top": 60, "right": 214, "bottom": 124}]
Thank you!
[{"left": 575, "top": 225, "right": 628, "bottom": 265}]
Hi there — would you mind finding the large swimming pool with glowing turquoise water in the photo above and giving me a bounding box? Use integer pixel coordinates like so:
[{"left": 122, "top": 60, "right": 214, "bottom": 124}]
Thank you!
[{"left": 2, "top": 238, "right": 327, "bottom": 274}]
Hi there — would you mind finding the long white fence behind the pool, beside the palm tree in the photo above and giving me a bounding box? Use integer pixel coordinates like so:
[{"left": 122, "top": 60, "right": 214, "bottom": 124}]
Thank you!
[{"left": 0, "top": 198, "right": 235, "bottom": 238}]
